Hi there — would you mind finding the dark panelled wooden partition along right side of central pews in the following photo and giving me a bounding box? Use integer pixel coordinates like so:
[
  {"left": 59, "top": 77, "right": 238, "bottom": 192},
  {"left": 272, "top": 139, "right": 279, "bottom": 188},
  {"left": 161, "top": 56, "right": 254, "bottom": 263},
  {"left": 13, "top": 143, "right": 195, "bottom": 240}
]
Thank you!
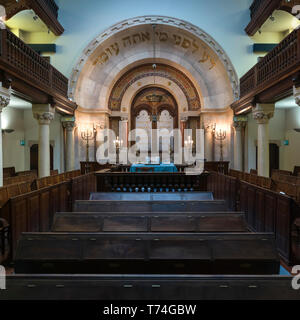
[{"left": 207, "top": 171, "right": 300, "bottom": 264}]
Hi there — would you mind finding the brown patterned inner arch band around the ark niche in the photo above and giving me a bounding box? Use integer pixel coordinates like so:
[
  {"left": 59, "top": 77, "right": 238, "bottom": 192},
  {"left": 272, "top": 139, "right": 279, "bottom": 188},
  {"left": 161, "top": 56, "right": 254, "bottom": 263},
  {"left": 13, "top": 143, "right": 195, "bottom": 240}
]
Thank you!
[{"left": 108, "top": 64, "right": 201, "bottom": 111}]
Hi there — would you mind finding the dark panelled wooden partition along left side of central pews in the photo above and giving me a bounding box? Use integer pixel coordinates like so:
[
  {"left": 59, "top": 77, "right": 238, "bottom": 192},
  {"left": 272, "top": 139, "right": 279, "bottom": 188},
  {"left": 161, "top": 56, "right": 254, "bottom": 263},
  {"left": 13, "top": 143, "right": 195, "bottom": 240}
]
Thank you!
[{"left": 0, "top": 173, "right": 96, "bottom": 256}]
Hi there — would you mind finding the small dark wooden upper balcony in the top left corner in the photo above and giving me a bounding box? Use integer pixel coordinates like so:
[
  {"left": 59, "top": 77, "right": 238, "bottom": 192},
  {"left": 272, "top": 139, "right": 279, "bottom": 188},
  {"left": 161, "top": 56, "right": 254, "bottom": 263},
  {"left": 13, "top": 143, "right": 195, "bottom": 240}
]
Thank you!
[{"left": 1, "top": 0, "right": 64, "bottom": 36}]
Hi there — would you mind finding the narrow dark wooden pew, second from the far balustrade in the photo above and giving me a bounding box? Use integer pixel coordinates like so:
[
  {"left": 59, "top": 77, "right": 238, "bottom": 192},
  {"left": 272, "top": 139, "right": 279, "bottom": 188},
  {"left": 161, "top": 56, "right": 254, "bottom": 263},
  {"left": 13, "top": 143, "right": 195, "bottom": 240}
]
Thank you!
[{"left": 73, "top": 200, "right": 228, "bottom": 212}]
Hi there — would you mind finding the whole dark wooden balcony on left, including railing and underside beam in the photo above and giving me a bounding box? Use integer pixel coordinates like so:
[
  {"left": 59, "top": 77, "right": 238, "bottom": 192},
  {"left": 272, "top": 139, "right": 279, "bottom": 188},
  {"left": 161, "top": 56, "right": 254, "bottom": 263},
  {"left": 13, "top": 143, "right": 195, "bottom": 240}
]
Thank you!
[{"left": 0, "top": 29, "right": 76, "bottom": 114}]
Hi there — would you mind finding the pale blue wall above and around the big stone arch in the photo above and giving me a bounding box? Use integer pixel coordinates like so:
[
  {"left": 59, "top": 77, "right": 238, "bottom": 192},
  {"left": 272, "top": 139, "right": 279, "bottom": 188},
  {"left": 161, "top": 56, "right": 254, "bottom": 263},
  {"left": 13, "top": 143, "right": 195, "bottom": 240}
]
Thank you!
[{"left": 51, "top": 0, "right": 257, "bottom": 77}]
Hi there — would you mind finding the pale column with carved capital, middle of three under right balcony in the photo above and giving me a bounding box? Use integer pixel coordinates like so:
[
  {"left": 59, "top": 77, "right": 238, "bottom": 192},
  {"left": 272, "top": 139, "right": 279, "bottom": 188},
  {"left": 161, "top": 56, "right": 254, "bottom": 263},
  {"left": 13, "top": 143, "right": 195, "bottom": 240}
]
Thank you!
[{"left": 252, "top": 104, "right": 274, "bottom": 177}]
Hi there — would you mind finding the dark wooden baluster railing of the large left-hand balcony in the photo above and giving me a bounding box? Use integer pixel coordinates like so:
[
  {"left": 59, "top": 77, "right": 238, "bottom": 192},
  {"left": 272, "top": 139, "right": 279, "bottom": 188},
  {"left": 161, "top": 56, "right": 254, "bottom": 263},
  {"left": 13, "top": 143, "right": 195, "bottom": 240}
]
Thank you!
[{"left": 0, "top": 29, "right": 68, "bottom": 98}]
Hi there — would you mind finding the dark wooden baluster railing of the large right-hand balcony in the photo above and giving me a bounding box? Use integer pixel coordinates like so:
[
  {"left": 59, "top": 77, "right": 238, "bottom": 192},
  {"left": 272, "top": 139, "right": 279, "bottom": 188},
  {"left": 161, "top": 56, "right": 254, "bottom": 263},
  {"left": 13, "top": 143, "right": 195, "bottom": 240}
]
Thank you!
[{"left": 240, "top": 30, "right": 300, "bottom": 98}]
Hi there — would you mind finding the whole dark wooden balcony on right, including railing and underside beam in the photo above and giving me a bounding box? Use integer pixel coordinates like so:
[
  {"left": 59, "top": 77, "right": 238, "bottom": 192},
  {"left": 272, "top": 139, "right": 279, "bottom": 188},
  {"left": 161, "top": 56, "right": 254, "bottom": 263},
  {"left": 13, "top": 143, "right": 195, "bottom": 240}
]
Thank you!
[{"left": 232, "top": 29, "right": 300, "bottom": 113}]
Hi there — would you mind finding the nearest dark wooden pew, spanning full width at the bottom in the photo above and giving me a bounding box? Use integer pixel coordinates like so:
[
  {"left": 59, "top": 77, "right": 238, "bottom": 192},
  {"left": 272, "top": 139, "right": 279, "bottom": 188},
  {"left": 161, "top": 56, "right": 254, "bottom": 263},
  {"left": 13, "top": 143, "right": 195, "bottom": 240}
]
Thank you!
[{"left": 0, "top": 274, "right": 300, "bottom": 301}]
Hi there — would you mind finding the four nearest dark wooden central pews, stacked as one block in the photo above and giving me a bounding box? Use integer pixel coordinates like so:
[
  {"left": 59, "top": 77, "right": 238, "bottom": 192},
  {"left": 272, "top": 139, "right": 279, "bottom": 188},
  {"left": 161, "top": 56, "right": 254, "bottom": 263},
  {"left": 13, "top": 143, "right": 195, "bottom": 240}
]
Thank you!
[{"left": 0, "top": 196, "right": 300, "bottom": 300}]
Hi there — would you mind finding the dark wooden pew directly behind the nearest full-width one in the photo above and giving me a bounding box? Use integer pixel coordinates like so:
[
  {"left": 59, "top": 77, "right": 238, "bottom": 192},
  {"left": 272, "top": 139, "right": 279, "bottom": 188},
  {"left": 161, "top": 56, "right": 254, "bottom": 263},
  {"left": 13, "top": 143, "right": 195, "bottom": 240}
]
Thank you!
[{"left": 15, "top": 233, "right": 280, "bottom": 275}]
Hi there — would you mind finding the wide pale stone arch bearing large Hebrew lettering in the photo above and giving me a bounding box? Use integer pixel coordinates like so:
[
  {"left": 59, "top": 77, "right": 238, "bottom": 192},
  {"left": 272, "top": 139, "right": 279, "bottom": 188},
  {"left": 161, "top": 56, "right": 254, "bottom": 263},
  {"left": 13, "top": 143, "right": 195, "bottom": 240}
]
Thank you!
[{"left": 69, "top": 16, "right": 239, "bottom": 110}]
